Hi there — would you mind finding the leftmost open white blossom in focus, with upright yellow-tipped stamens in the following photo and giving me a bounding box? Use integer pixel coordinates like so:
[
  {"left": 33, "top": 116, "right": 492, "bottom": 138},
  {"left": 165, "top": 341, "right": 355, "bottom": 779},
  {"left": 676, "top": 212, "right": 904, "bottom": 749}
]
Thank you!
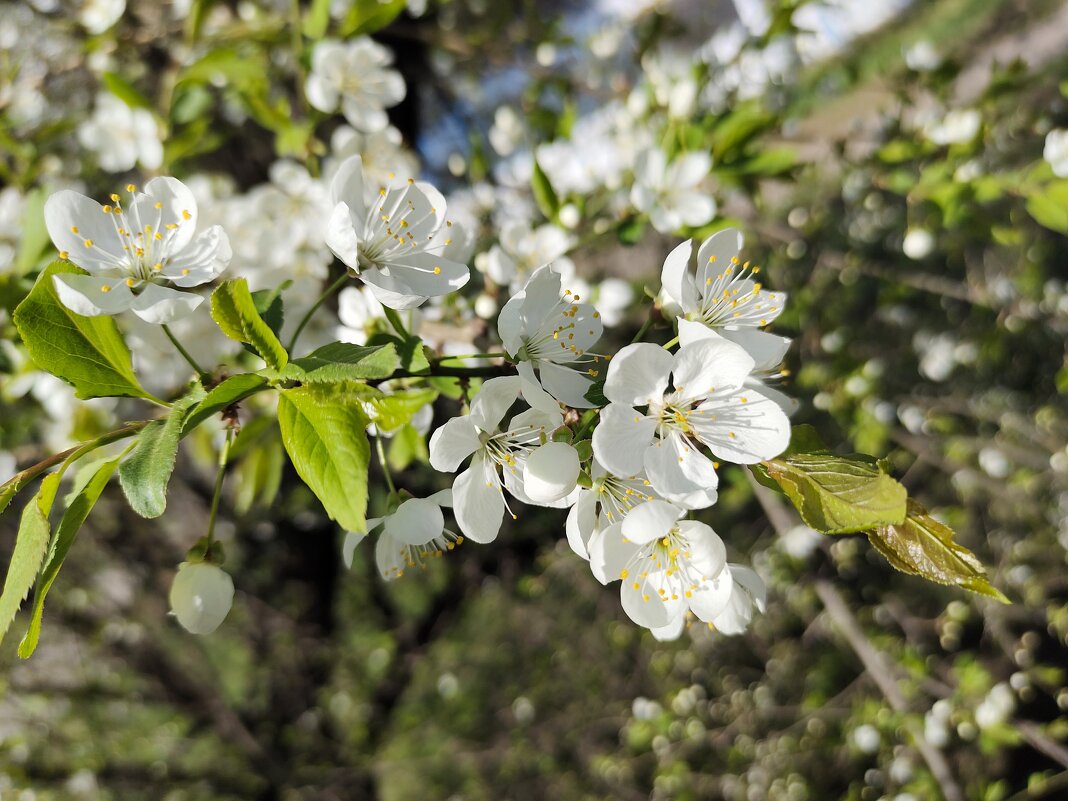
[{"left": 45, "top": 177, "right": 231, "bottom": 323}]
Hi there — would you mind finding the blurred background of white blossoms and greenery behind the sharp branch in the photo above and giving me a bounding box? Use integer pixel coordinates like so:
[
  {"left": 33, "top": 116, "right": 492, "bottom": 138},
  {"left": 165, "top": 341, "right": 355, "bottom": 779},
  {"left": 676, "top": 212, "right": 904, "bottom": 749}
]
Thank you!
[{"left": 0, "top": 0, "right": 1068, "bottom": 801}]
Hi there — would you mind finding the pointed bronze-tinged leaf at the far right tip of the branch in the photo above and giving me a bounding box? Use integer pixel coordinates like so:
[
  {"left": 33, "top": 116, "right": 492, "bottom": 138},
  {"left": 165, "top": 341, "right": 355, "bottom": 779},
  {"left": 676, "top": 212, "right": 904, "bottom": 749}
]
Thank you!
[{"left": 867, "top": 498, "right": 1010, "bottom": 603}]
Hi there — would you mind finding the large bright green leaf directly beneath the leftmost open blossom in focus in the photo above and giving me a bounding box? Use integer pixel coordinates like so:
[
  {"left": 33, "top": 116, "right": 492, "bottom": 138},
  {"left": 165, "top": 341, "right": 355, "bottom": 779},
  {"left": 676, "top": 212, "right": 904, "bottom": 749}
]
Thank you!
[{"left": 15, "top": 262, "right": 156, "bottom": 401}]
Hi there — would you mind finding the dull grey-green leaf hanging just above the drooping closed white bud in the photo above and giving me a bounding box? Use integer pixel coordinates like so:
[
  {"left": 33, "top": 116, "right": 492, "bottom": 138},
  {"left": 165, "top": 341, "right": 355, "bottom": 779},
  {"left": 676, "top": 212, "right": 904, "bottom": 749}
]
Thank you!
[{"left": 119, "top": 387, "right": 204, "bottom": 518}]
